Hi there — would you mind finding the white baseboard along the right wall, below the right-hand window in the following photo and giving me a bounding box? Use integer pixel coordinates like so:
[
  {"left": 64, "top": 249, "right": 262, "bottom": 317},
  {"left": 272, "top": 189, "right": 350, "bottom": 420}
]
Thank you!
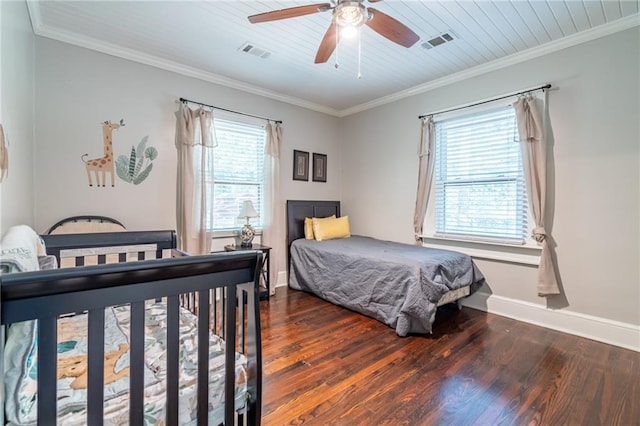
[{"left": 462, "top": 292, "right": 640, "bottom": 352}]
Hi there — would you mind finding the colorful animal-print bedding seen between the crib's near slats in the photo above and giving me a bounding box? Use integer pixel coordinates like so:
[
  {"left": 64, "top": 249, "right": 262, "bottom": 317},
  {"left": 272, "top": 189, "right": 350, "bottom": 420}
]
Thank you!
[{"left": 4, "top": 302, "right": 247, "bottom": 426}]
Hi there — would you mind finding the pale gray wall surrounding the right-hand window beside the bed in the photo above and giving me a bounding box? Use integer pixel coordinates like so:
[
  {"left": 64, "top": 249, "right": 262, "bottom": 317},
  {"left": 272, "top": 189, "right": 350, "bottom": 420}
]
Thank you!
[{"left": 341, "top": 27, "right": 640, "bottom": 332}]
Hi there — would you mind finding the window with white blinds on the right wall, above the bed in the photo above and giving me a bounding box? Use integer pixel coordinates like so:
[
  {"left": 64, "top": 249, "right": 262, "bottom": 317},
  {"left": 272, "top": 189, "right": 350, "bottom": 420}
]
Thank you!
[{"left": 434, "top": 107, "right": 528, "bottom": 244}]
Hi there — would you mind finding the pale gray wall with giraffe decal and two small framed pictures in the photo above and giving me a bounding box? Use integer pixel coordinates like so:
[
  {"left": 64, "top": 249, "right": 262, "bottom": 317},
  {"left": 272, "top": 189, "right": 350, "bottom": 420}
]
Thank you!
[{"left": 35, "top": 37, "right": 342, "bottom": 238}]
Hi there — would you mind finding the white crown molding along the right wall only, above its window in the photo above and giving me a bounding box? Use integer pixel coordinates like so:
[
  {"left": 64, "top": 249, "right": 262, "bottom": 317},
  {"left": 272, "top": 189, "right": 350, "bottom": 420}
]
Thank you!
[{"left": 339, "top": 13, "right": 640, "bottom": 117}]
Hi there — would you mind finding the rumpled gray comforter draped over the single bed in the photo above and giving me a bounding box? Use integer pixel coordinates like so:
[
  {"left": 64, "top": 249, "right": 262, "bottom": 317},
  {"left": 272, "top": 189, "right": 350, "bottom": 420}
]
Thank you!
[{"left": 289, "top": 236, "right": 484, "bottom": 336}]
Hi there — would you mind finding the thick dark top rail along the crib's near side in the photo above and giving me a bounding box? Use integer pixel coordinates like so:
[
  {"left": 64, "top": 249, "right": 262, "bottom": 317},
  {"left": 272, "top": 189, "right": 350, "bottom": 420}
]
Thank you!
[{"left": 2, "top": 252, "right": 256, "bottom": 304}]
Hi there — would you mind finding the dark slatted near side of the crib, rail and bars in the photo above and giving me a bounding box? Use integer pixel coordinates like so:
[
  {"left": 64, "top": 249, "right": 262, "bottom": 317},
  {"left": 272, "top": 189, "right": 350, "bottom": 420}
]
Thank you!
[{"left": 0, "top": 251, "right": 262, "bottom": 425}]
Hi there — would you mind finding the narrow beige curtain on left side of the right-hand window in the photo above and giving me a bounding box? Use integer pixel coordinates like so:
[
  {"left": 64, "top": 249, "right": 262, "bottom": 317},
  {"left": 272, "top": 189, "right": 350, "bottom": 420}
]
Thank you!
[{"left": 413, "top": 116, "right": 434, "bottom": 244}]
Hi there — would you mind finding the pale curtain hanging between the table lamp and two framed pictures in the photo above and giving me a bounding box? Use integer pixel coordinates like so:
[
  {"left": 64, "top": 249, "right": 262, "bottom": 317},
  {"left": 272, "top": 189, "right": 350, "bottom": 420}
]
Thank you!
[{"left": 261, "top": 122, "right": 285, "bottom": 289}]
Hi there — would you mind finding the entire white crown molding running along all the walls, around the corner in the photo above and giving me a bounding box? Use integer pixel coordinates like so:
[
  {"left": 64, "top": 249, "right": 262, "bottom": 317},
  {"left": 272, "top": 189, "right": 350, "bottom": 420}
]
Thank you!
[{"left": 27, "top": 0, "right": 640, "bottom": 117}]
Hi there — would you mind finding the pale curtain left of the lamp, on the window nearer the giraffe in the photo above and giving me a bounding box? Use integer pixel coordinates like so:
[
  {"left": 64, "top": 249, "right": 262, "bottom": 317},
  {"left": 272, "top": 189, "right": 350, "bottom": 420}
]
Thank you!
[{"left": 176, "top": 103, "right": 216, "bottom": 254}]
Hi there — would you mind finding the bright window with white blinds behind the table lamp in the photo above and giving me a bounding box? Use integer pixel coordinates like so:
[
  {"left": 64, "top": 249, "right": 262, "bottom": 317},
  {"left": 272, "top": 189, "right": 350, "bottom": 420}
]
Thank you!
[{"left": 206, "top": 118, "right": 266, "bottom": 231}]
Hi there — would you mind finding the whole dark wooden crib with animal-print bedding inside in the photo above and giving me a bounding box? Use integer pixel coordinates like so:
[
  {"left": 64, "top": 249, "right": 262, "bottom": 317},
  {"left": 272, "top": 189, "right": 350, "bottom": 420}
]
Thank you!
[{"left": 0, "top": 226, "right": 262, "bottom": 426}]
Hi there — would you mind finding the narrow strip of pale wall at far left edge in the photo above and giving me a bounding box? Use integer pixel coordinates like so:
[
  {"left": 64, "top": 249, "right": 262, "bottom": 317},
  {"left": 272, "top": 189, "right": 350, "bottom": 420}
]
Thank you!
[{"left": 0, "top": 2, "right": 35, "bottom": 234}]
